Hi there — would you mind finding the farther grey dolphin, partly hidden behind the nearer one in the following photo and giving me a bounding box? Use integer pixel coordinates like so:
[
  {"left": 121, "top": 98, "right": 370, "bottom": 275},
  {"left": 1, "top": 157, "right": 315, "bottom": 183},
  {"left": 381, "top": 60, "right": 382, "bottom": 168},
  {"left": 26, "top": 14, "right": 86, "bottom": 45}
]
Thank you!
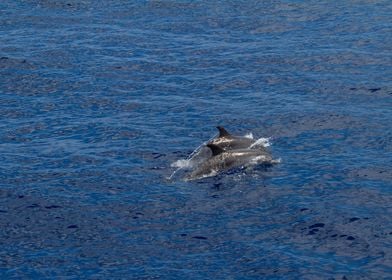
[{"left": 209, "top": 126, "right": 262, "bottom": 150}]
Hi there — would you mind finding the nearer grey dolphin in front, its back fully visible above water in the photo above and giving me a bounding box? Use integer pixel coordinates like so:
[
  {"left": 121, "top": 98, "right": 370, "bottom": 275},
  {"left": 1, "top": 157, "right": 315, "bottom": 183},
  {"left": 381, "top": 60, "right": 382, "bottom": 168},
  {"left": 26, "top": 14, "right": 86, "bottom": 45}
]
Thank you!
[{"left": 186, "top": 143, "right": 273, "bottom": 180}]
